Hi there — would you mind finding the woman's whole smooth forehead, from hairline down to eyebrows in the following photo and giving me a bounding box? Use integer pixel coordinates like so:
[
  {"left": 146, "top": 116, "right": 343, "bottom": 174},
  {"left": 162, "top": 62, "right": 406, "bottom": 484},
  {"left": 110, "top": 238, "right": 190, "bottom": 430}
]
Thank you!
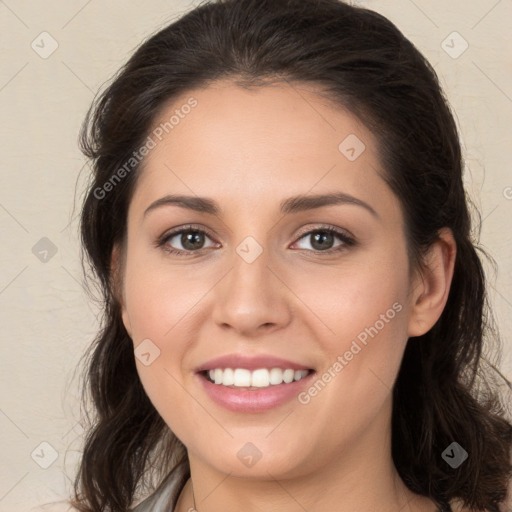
[{"left": 130, "top": 82, "right": 390, "bottom": 215}]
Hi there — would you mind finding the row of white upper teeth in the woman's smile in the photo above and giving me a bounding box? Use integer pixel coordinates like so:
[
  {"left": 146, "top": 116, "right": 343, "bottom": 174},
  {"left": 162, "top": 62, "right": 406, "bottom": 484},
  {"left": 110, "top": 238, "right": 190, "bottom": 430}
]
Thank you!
[{"left": 208, "top": 368, "right": 309, "bottom": 388}]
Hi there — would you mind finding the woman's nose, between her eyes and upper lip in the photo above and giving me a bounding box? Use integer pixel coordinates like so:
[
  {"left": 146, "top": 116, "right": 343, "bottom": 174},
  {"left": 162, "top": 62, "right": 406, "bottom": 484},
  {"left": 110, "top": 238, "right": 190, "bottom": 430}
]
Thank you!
[{"left": 213, "top": 244, "right": 294, "bottom": 338}]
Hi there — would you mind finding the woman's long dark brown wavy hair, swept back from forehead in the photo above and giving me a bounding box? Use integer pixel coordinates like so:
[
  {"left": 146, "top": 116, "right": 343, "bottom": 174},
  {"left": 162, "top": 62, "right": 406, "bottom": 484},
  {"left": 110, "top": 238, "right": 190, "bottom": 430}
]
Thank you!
[{"left": 70, "top": 0, "right": 512, "bottom": 512}]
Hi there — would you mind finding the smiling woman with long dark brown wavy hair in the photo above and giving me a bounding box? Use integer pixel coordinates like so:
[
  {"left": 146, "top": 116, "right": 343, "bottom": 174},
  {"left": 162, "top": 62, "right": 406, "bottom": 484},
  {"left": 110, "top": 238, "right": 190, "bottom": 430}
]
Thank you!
[{"left": 71, "top": 0, "right": 512, "bottom": 512}]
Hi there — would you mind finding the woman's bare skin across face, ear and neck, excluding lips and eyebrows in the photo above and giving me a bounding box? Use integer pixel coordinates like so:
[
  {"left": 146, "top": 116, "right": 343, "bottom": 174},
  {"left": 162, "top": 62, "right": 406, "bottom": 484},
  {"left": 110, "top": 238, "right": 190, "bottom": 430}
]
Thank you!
[{"left": 113, "top": 81, "right": 456, "bottom": 512}]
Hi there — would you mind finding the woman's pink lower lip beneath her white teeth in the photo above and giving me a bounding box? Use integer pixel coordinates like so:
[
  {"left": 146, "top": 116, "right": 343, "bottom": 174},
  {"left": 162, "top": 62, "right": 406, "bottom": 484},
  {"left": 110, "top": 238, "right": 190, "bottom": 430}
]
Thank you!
[{"left": 196, "top": 372, "right": 315, "bottom": 412}]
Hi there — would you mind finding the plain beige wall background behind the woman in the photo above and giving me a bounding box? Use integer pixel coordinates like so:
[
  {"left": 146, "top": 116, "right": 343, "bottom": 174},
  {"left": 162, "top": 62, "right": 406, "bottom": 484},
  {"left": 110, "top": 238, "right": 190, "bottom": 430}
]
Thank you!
[{"left": 0, "top": 0, "right": 512, "bottom": 512}]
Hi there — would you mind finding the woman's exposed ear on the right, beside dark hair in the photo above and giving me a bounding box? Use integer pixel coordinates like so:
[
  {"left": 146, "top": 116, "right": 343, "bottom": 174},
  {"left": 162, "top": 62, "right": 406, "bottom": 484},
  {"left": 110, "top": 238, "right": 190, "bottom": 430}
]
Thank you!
[{"left": 408, "top": 228, "right": 457, "bottom": 336}]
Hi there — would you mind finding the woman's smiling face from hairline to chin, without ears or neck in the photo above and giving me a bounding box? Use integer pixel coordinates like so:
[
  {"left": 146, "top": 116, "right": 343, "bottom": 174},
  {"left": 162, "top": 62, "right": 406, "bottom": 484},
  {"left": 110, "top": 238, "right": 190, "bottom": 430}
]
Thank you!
[{"left": 122, "top": 82, "right": 424, "bottom": 477}]
